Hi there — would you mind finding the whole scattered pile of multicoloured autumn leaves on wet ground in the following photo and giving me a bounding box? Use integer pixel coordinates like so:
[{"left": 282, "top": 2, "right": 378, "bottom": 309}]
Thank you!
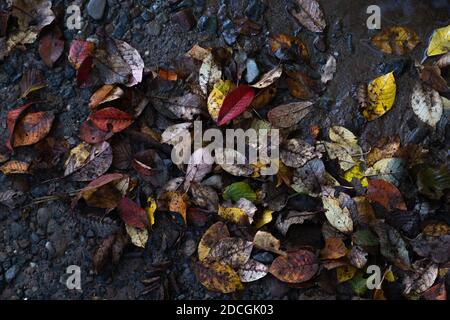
[{"left": 0, "top": 0, "right": 450, "bottom": 299}]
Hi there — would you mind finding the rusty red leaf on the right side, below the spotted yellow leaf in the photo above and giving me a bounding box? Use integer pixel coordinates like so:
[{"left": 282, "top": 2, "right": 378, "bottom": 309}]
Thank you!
[{"left": 367, "top": 179, "right": 407, "bottom": 211}]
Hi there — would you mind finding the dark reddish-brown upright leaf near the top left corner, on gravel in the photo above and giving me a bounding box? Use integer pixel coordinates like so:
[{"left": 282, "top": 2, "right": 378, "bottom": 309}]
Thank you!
[{"left": 39, "top": 25, "right": 64, "bottom": 68}]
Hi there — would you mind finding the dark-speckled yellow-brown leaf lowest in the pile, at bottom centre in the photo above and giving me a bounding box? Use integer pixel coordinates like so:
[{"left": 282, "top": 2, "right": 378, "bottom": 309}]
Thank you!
[{"left": 194, "top": 262, "right": 244, "bottom": 293}]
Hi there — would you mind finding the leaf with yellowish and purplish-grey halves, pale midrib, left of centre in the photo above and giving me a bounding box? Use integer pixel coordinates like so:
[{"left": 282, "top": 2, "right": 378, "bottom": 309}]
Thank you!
[{"left": 64, "top": 142, "right": 112, "bottom": 181}]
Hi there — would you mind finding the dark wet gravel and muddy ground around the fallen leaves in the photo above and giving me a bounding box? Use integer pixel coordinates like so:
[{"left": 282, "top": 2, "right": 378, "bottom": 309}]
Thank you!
[{"left": 0, "top": 0, "right": 450, "bottom": 299}]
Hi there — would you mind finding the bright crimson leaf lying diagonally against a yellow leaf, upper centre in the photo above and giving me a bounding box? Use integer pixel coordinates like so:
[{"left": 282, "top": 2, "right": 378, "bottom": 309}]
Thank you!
[{"left": 217, "top": 85, "right": 255, "bottom": 126}]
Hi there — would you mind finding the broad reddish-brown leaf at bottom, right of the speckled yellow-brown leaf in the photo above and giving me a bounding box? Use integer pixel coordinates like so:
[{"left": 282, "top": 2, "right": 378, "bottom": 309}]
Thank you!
[{"left": 269, "top": 250, "right": 319, "bottom": 283}]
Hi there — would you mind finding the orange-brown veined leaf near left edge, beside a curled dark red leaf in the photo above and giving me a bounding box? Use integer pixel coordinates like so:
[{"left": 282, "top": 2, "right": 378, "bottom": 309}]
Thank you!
[{"left": 12, "top": 111, "right": 55, "bottom": 148}]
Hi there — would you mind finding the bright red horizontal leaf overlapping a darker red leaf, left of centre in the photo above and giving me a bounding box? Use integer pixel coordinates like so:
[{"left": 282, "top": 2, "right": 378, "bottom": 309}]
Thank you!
[{"left": 89, "top": 107, "right": 133, "bottom": 133}]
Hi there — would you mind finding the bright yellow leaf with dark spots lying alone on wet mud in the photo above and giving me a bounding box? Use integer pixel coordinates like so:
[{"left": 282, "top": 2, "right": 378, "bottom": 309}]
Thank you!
[{"left": 362, "top": 72, "right": 397, "bottom": 121}]
